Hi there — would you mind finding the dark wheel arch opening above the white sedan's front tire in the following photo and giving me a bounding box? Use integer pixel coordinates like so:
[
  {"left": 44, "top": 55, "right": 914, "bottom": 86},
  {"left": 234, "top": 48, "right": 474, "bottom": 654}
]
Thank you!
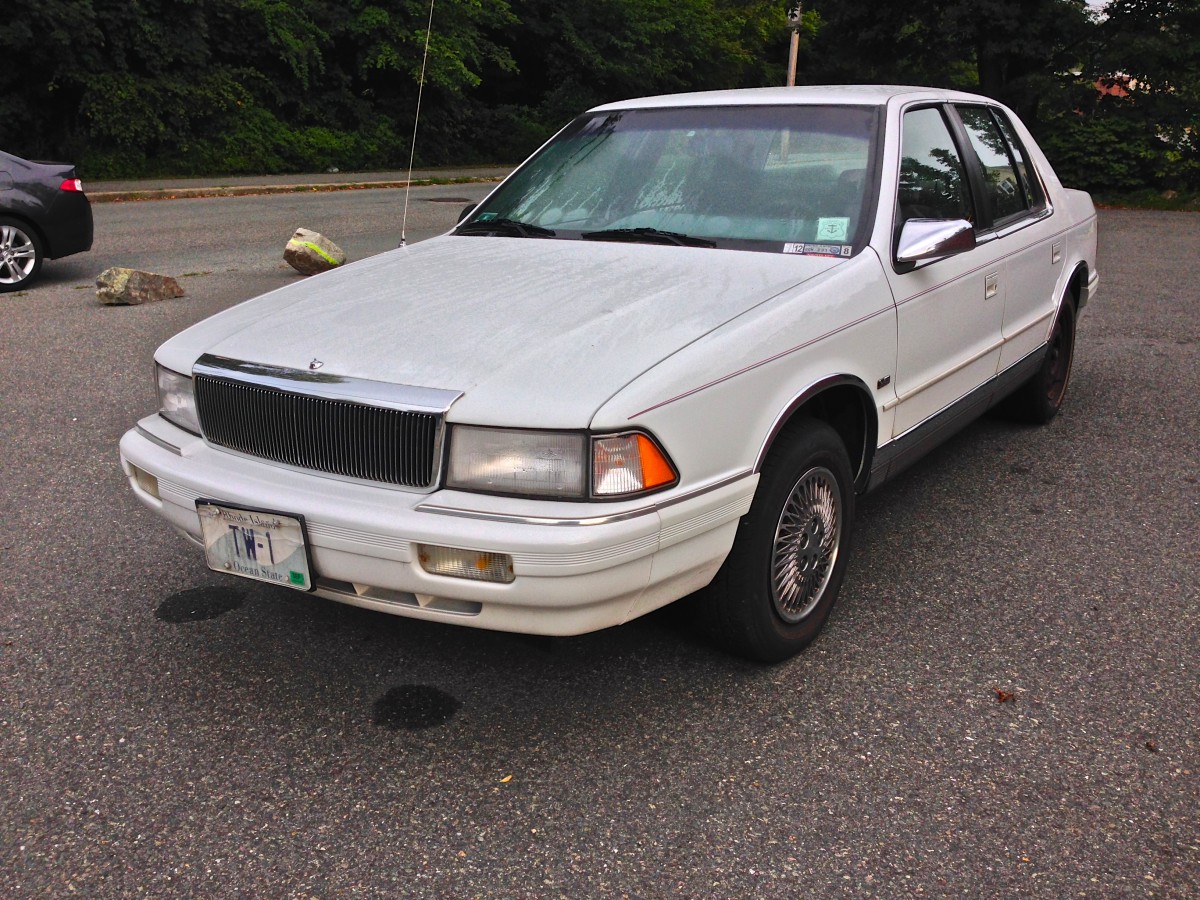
[{"left": 754, "top": 374, "right": 880, "bottom": 493}]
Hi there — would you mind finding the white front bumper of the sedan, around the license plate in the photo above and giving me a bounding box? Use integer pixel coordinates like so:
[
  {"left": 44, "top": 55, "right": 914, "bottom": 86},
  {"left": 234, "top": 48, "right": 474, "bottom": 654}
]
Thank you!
[{"left": 121, "top": 415, "right": 757, "bottom": 635}]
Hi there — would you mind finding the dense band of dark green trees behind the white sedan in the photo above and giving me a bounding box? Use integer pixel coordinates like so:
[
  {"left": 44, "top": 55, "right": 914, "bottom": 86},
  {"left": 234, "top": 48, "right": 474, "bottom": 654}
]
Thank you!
[{"left": 0, "top": 0, "right": 1200, "bottom": 190}]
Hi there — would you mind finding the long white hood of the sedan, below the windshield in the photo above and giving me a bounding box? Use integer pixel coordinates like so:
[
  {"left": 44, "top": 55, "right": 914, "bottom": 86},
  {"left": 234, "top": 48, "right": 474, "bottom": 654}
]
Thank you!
[{"left": 156, "top": 235, "right": 841, "bottom": 428}]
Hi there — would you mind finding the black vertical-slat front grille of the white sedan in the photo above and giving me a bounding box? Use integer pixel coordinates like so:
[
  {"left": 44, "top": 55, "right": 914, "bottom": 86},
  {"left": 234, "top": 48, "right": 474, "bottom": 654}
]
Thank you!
[{"left": 196, "top": 374, "right": 442, "bottom": 487}]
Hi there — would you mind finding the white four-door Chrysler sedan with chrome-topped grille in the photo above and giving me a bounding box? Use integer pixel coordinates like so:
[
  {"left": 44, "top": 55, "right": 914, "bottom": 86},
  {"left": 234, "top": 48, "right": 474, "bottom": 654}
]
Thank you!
[{"left": 121, "top": 86, "right": 1097, "bottom": 661}]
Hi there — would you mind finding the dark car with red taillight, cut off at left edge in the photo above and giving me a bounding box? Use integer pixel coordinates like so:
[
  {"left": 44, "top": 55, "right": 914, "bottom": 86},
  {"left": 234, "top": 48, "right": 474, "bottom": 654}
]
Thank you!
[{"left": 0, "top": 151, "right": 91, "bottom": 293}]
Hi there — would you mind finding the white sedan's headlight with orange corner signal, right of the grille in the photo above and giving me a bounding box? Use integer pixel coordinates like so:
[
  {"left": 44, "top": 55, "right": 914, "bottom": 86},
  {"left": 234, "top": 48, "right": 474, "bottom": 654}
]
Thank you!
[{"left": 446, "top": 425, "right": 679, "bottom": 499}]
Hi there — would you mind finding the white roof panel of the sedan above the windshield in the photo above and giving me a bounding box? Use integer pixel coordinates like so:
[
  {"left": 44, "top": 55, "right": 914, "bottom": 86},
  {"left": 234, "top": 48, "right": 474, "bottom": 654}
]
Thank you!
[{"left": 589, "top": 84, "right": 990, "bottom": 112}]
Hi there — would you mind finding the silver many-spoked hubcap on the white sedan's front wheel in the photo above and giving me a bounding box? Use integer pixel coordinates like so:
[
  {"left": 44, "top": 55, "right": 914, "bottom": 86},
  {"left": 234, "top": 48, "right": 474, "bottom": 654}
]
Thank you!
[{"left": 770, "top": 467, "right": 841, "bottom": 624}]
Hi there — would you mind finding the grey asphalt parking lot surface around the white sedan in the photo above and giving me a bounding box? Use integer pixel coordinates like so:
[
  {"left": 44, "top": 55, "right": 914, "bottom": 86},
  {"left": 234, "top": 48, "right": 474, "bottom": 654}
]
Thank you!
[{"left": 0, "top": 185, "right": 1200, "bottom": 898}]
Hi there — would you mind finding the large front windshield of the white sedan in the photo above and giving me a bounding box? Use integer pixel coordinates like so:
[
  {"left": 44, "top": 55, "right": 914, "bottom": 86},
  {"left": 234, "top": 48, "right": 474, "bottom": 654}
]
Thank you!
[{"left": 458, "top": 106, "right": 878, "bottom": 256}]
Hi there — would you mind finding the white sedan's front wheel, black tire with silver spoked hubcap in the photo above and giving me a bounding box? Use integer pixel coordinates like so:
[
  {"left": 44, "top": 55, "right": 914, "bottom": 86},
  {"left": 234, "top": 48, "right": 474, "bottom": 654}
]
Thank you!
[{"left": 700, "top": 419, "right": 854, "bottom": 662}]
